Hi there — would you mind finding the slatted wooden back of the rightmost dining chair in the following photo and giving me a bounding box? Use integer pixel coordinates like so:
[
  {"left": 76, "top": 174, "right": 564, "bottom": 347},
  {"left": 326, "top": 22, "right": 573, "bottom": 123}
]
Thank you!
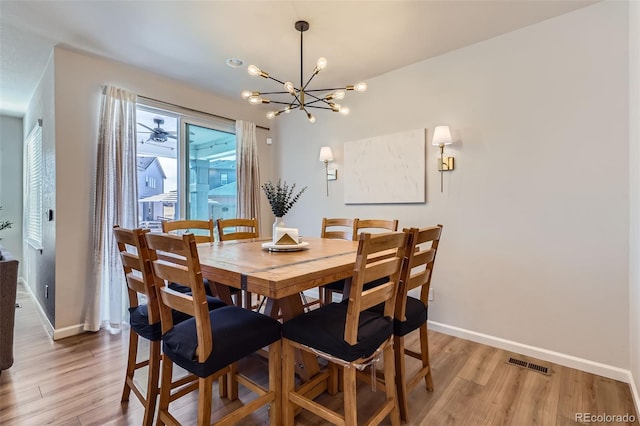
[{"left": 395, "top": 225, "right": 442, "bottom": 321}]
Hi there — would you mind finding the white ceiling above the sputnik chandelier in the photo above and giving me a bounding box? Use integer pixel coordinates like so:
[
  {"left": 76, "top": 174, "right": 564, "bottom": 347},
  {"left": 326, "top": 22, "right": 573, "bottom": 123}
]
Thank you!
[{"left": 0, "top": 0, "right": 596, "bottom": 116}]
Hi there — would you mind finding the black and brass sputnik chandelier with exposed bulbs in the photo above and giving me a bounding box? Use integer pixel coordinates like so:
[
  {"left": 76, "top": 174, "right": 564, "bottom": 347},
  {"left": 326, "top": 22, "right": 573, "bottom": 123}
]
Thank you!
[{"left": 242, "top": 21, "right": 367, "bottom": 123}]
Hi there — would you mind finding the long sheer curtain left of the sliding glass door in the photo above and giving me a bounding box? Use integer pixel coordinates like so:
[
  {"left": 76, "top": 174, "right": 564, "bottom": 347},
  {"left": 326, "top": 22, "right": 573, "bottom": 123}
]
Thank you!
[{"left": 84, "top": 86, "right": 138, "bottom": 331}]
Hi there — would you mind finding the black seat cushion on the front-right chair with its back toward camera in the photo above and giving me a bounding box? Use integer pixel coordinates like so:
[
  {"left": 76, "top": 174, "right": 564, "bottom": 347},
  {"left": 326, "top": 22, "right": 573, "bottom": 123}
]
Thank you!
[{"left": 282, "top": 303, "right": 393, "bottom": 361}]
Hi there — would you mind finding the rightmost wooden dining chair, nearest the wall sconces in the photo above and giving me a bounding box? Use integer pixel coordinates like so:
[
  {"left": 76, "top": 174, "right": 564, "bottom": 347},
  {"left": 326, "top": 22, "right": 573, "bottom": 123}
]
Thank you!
[{"left": 393, "top": 225, "right": 442, "bottom": 422}]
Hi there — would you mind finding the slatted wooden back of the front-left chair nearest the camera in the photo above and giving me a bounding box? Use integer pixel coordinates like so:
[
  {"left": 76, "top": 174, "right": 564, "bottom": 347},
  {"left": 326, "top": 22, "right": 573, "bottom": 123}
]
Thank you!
[{"left": 145, "top": 233, "right": 213, "bottom": 362}]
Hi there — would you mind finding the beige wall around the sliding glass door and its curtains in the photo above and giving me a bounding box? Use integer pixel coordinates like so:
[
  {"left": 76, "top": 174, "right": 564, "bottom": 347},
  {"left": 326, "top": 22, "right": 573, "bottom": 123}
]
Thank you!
[{"left": 25, "top": 48, "right": 273, "bottom": 337}]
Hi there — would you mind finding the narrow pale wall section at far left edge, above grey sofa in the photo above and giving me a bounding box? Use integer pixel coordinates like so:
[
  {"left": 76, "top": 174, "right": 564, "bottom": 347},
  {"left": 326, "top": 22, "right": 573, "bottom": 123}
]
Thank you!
[{"left": 0, "top": 115, "right": 23, "bottom": 266}]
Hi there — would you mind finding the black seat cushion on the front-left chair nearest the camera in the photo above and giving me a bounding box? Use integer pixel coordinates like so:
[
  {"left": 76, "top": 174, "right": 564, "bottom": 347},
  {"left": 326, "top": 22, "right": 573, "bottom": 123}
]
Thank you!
[{"left": 162, "top": 306, "right": 281, "bottom": 377}]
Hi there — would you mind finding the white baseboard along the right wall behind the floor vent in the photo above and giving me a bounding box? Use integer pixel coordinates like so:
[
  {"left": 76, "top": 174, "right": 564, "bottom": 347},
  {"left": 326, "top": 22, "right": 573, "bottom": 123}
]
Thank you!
[{"left": 428, "top": 321, "right": 638, "bottom": 382}]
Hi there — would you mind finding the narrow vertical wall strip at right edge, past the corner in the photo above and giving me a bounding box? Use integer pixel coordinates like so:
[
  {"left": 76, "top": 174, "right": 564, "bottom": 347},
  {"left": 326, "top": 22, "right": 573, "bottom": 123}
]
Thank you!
[{"left": 629, "top": 1, "right": 640, "bottom": 412}]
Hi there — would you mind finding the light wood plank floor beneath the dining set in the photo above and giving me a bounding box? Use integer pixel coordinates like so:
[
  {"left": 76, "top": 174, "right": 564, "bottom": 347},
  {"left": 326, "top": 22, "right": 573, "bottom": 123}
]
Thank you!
[{"left": 0, "top": 282, "right": 638, "bottom": 426}]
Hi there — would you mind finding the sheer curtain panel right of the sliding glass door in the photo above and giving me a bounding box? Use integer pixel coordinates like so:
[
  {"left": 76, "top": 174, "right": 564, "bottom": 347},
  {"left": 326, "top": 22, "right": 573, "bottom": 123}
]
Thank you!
[{"left": 236, "top": 120, "right": 261, "bottom": 233}]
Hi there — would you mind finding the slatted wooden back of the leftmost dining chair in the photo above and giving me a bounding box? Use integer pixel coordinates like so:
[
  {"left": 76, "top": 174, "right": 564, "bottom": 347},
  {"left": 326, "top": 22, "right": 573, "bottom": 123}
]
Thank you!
[{"left": 113, "top": 225, "right": 160, "bottom": 324}]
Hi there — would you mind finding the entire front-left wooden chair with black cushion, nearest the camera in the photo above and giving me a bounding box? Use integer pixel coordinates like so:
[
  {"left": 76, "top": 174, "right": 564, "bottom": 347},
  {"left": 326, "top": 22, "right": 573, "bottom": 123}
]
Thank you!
[{"left": 145, "top": 233, "right": 281, "bottom": 426}]
